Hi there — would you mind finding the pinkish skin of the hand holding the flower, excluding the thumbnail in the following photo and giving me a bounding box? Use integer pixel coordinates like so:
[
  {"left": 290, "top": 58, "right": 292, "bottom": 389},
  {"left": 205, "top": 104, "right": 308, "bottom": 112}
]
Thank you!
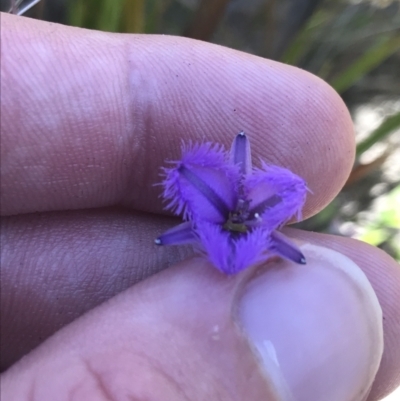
[{"left": 1, "top": 14, "right": 400, "bottom": 400}]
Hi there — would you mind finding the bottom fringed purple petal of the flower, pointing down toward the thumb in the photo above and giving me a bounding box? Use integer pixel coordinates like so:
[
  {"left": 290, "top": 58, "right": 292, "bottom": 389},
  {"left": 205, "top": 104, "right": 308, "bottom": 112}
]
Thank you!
[{"left": 197, "top": 223, "right": 271, "bottom": 274}]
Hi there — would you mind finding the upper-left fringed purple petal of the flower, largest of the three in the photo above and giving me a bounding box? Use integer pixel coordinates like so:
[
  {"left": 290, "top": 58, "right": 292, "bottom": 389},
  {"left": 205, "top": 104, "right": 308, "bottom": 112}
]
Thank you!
[{"left": 163, "top": 143, "right": 240, "bottom": 223}]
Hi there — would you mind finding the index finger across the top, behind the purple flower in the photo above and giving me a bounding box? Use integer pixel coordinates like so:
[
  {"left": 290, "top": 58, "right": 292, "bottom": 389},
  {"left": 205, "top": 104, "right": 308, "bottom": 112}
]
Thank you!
[{"left": 1, "top": 14, "right": 354, "bottom": 217}]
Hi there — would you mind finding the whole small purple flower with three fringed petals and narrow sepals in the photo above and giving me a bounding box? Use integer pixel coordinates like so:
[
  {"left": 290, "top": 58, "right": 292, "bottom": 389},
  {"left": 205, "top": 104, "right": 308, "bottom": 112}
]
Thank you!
[{"left": 155, "top": 132, "right": 307, "bottom": 274}]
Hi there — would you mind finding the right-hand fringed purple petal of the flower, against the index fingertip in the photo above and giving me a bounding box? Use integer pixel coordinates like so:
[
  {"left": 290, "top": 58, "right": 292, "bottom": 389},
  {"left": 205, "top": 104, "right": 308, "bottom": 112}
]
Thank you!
[{"left": 244, "top": 163, "right": 307, "bottom": 230}]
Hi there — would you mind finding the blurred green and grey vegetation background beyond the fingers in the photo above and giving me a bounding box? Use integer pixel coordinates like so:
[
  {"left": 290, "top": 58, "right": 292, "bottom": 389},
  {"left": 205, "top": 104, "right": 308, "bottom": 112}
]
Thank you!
[{"left": 6, "top": 0, "right": 400, "bottom": 261}]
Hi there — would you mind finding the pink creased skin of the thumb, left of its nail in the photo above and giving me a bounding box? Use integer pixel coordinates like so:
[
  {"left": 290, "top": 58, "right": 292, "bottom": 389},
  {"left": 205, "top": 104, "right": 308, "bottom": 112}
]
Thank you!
[{"left": 3, "top": 258, "right": 277, "bottom": 401}]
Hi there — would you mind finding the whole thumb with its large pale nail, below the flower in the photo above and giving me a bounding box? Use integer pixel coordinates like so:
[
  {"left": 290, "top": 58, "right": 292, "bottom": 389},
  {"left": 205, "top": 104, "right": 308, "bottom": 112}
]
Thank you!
[{"left": 2, "top": 244, "right": 383, "bottom": 401}]
